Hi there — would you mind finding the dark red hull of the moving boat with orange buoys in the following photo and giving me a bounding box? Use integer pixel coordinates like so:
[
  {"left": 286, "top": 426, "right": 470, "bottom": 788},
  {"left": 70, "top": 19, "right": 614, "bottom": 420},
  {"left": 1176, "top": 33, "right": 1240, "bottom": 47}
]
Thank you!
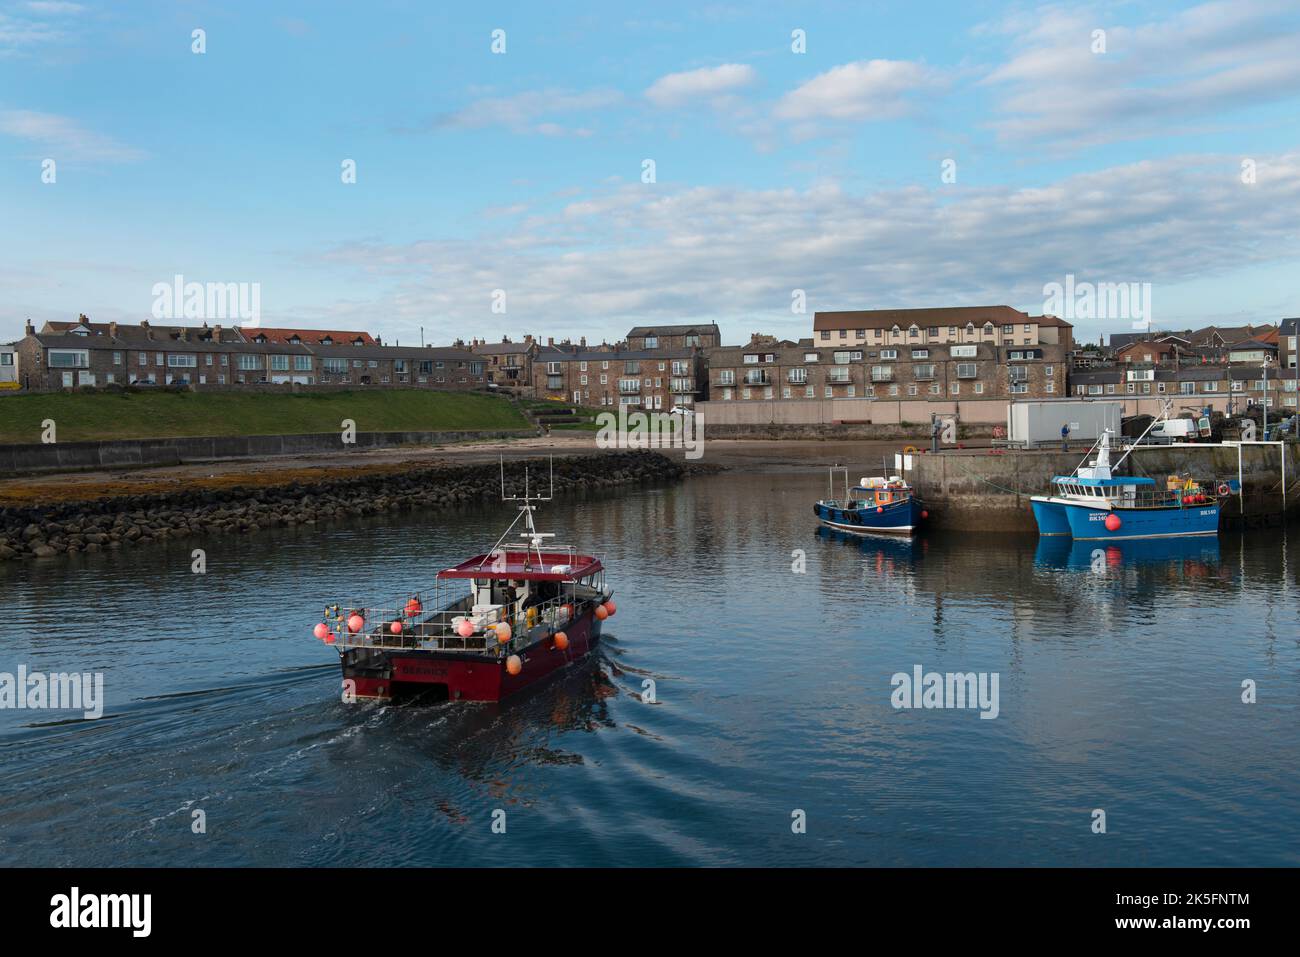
[{"left": 341, "top": 609, "right": 602, "bottom": 701}]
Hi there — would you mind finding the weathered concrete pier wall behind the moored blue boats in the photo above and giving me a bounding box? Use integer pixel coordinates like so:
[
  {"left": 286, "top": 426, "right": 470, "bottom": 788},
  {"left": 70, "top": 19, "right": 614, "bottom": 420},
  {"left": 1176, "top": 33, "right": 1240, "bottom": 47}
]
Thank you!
[{"left": 907, "top": 442, "right": 1300, "bottom": 532}]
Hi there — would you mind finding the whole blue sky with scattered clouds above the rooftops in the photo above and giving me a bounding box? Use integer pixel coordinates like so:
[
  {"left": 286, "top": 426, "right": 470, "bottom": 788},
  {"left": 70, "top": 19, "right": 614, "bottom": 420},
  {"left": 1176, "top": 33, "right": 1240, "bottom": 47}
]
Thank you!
[{"left": 0, "top": 0, "right": 1300, "bottom": 345}]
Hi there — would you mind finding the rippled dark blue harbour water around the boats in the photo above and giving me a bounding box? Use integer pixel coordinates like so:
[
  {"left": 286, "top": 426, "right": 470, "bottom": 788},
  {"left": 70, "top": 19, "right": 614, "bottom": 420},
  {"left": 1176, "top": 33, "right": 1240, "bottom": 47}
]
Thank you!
[{"left": 0, "top": 473, "right": 1300, "bottom": 866}]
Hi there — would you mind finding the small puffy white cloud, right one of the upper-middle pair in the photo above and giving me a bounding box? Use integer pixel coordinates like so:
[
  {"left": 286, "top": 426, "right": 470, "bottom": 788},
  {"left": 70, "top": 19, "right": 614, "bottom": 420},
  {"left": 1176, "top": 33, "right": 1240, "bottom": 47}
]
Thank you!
[{"left": 775, "top": 60, "right": 944, "bottom": 121}]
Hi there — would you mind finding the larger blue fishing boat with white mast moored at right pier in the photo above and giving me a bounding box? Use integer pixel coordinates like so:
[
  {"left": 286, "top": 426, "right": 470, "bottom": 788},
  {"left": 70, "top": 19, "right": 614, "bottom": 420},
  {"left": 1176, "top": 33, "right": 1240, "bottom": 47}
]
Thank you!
[{"left": 1030, "top": 429, "right": 1219, "bottom": 541}]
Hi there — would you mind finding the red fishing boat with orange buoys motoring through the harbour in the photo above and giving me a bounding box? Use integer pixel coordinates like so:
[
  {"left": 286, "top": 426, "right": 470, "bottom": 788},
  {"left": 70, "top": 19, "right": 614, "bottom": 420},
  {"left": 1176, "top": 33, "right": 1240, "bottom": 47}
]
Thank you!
[{"left": 315, "top": 465, "right": 616, "bottom": 701}]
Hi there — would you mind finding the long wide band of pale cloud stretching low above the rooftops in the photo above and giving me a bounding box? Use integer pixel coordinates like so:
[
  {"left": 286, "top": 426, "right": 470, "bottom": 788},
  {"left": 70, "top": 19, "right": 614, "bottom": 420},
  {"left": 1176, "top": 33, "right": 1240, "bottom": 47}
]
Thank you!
[{"left": 312, "top": 153, "right": 1300, "bottom": 338}]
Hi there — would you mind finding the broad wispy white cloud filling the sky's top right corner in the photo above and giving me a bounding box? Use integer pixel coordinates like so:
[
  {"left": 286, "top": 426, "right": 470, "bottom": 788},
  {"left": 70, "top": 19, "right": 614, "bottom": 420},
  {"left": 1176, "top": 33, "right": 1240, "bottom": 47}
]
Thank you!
[{"left": 980, "top": 0, "right": 1300, "bottom": 147}]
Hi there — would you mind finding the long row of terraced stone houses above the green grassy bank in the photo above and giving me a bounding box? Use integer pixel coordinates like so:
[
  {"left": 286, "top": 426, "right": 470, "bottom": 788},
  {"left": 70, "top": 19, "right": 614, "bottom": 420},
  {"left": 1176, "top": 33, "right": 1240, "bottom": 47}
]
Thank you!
[{"left": 14, "top": 317, "right": 485, "bottom": 389}]
